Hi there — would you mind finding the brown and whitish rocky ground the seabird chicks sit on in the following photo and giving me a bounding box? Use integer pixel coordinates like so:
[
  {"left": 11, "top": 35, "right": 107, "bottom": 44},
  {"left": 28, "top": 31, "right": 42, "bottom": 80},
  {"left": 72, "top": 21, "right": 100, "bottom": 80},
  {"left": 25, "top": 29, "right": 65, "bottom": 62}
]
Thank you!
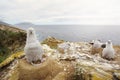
[{"left": 0, "top": 37, "right": 120, "bottom": 80}]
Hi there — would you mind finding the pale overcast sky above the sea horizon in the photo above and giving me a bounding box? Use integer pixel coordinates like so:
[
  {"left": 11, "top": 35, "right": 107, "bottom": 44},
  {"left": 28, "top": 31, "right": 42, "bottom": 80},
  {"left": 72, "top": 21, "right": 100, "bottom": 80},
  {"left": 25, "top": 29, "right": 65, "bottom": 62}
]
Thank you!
[{"left": 0, "top": 0, "right": 120, "bottom": 25}]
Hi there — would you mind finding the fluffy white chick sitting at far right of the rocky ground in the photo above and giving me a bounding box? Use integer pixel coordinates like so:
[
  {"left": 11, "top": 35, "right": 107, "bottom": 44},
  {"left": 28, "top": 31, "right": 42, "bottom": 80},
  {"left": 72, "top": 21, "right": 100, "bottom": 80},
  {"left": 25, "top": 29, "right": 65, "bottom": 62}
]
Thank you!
[{"left": 102, "top": 40, "right": 115, "bottom": 59}]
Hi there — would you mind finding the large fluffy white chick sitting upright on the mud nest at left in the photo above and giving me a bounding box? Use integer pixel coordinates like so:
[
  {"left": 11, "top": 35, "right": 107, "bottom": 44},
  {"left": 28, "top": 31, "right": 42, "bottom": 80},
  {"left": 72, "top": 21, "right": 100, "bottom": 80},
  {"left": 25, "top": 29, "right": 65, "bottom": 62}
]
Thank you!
[{"left": 24, "top": 28, "right": 43, "bottom": 63}]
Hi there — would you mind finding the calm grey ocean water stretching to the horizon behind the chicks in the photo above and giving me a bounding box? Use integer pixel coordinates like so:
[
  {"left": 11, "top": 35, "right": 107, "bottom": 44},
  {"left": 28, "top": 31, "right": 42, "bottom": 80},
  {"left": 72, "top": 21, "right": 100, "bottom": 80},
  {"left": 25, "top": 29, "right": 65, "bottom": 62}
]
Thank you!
[{"left": 17, "top": 25, "right": 120, "bottom": 45}]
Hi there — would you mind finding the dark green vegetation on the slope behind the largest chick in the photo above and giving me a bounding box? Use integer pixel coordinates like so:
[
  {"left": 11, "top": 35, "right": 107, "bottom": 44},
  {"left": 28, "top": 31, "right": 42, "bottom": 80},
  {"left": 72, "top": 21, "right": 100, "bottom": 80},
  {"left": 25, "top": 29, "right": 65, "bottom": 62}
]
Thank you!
[{"left": 0, "top": 29, "right": 26, "bottom": 63}]
